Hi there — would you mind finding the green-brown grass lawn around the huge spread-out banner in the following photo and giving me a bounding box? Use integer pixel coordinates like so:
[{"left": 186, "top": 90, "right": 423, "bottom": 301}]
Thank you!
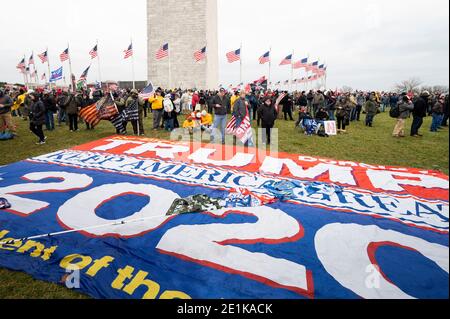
[{"left": 0, "top": 113, "right": 449, "bottom": 299}]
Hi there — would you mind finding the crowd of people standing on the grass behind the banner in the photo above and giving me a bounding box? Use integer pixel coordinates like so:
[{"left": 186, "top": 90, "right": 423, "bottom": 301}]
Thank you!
[{"left": 0, "top": 84, "right": 449, "bottom": 144}]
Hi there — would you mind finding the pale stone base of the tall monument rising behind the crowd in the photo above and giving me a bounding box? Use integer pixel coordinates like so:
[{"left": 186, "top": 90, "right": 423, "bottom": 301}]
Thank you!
[{"left": 147, "top": 0, "right": 219, "bottom": 89}]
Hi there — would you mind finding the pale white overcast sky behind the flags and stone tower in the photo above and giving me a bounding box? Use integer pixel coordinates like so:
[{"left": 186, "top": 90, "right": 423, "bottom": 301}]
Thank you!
[{"left": 0, "top": 0, "right": 449, "bottom": 90}]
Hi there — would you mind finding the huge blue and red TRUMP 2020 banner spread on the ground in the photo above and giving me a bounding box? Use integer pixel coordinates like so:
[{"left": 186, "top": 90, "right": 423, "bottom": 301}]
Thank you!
[{"left": 0, "top": 136, "right": 449, "bottom": 299}]
